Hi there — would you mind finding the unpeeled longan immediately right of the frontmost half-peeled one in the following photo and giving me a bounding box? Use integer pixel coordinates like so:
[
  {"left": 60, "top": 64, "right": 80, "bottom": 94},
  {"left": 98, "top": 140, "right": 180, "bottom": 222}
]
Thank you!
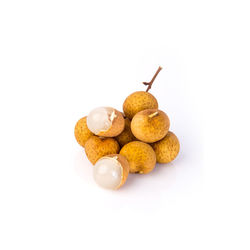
[{"left": 120, "top": 141, "right": 156, "bottom": 174}]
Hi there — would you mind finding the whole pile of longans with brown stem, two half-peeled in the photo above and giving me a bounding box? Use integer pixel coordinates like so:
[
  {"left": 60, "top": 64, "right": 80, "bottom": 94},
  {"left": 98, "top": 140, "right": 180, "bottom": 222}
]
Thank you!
[{"left": 75, "top": 67, "right": 180, "bottom": 189}]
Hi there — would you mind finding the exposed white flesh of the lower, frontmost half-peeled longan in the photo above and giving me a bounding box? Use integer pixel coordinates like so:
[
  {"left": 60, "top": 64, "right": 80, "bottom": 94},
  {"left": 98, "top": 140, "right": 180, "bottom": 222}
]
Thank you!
[{"left": 93, "top": 157, "right": 123, "bottom": 189}]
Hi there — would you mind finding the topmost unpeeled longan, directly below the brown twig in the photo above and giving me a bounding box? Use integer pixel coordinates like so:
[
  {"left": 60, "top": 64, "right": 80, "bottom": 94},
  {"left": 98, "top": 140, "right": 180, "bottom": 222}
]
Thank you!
[{"left": 123, "top": 91, "right": 158, "bottom": 119}]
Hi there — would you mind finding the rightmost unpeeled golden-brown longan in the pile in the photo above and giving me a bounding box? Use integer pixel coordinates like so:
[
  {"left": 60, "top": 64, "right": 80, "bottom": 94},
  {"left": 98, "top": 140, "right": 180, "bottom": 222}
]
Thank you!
[{"left": 151, "top": 131, "right": 180, "bottom": 163}]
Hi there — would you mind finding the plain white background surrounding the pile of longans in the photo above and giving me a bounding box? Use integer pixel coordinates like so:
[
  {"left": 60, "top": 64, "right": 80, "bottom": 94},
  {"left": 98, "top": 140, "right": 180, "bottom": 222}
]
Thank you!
[{"left": 0, "top": 0, "right": 250, "bottom": 250}]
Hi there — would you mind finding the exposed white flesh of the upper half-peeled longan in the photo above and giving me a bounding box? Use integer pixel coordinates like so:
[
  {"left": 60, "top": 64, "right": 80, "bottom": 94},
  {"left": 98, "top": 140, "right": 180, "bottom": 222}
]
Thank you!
[{"left": 87, "top": 107, "right": 116, "bottom": 135}]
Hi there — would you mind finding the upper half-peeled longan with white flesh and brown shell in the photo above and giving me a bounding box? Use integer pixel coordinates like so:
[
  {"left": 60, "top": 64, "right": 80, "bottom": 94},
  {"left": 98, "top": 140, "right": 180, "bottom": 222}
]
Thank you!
[{"left": 87, "top": 107, "right": 125, "bottom": 137}]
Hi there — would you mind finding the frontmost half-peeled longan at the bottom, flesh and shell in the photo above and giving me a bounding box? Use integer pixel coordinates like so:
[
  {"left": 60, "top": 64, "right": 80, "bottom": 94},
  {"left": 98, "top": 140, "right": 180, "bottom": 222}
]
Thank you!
[{"left": 93, "top": 154, "right": 129, "bottom": 189}]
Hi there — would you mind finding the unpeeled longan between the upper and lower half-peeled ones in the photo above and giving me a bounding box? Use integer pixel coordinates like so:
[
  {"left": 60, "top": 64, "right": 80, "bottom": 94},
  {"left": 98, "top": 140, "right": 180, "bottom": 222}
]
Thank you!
[{"left": 85, "top": 136, "right": 120, "bottom": 164}]
